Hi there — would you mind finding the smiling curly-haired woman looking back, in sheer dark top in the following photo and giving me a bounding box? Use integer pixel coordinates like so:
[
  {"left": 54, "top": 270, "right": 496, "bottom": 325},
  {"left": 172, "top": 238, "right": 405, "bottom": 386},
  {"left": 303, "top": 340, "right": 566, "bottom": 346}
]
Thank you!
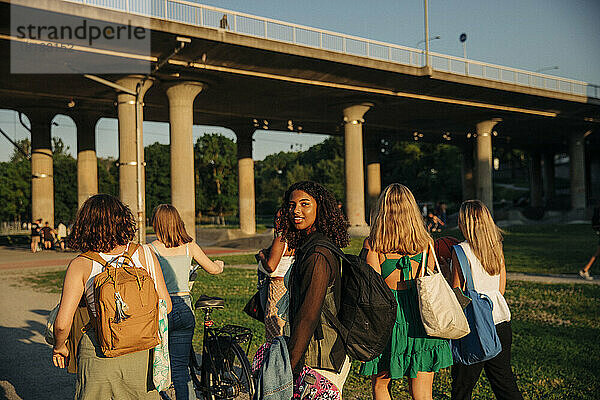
[{"left": 281, "top": 181, "right": 350, "bottom": 392}]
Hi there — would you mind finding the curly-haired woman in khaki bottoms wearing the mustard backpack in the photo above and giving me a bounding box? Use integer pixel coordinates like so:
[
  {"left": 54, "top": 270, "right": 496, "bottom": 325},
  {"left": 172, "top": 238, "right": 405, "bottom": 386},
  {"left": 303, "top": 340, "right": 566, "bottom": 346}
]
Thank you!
[{"left": 52, "top": 194, "right": 171, "bottom": 399}]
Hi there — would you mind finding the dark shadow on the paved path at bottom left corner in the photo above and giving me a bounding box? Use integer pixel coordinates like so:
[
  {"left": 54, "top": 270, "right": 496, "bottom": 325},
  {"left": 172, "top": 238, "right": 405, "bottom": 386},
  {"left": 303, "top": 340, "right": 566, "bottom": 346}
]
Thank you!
[{"left": 0, "top": 320, "right": 75, "bottom": 400}]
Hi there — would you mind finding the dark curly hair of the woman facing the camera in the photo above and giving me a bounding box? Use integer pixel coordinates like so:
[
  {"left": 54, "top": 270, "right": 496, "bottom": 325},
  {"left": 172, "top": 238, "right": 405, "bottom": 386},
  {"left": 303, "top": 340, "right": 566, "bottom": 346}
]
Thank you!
[{"left": 276, "top": 181, "right": 350, "bottom": 249}]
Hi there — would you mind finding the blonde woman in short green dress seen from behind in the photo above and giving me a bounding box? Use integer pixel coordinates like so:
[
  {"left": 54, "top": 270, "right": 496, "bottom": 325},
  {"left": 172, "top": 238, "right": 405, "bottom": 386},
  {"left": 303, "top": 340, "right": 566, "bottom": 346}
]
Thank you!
[{"left": 360, "top": 183, "right": 452, "bottom": 400}]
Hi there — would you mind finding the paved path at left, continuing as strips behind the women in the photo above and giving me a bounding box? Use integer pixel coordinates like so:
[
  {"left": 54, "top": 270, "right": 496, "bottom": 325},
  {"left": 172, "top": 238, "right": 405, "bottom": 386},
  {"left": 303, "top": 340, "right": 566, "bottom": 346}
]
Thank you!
[{"left": 0, "top": 247, "right": 600, "bottom": 400}]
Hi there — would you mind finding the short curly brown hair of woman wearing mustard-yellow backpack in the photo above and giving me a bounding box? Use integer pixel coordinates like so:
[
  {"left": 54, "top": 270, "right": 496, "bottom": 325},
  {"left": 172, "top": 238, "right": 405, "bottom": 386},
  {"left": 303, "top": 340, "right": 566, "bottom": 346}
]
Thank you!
[{"left": 68, "top": 194, "right": 137, "bottom": 252}]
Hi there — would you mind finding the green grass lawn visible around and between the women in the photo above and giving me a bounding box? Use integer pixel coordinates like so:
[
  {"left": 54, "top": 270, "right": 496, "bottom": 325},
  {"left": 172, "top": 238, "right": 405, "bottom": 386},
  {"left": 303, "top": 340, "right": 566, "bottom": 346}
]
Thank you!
[{"left": 28, "top": 268, "right": 600, "bottom": 400}]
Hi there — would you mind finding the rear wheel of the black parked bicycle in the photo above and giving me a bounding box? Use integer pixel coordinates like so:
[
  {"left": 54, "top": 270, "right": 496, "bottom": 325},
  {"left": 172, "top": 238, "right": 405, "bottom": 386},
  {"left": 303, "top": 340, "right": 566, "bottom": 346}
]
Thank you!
[{"left": 201, "top": 336, "right": 254, "bottom": 400}]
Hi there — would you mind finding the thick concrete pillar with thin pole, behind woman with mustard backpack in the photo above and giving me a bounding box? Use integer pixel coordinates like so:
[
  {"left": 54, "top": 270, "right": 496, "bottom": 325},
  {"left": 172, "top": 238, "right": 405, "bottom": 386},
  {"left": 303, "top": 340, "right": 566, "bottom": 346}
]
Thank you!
[{"left": 117, "top": 75, "right": 153, "bottom": 243}]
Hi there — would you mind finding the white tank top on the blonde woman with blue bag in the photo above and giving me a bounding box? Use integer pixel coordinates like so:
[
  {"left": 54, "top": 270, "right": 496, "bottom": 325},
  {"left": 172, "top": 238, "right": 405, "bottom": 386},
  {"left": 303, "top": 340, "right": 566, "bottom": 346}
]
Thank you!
[{"left": 453, "top": 241, "right": 510, "bottom": 325}]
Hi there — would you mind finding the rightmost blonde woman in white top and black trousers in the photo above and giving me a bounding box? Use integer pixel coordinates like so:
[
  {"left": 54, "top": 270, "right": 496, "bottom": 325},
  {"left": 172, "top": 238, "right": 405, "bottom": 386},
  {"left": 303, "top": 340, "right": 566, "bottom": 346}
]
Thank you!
[{"left": 451, "top": 200, "right": 523, "bottom": 400}]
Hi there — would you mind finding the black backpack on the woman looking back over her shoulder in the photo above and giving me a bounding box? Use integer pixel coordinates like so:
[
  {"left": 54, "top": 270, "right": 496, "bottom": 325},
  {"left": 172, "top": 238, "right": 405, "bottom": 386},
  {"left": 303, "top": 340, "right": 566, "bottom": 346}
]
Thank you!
[{"left": 316, "top": 241, "right": 397, "bottom": 361}]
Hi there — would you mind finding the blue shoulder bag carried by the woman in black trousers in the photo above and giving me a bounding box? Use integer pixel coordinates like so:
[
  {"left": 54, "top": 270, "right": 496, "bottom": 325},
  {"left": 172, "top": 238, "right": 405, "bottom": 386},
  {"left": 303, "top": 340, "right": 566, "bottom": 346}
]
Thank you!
[{"left": 450, "top": 245, "right": 502, "bottom": 365}]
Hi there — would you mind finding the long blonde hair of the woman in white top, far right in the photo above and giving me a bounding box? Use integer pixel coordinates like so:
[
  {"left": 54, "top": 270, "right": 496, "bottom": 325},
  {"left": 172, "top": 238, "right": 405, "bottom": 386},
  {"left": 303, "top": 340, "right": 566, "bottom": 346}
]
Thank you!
[{"left": 458, "top": 200, "right": 504, "bottom": 275}]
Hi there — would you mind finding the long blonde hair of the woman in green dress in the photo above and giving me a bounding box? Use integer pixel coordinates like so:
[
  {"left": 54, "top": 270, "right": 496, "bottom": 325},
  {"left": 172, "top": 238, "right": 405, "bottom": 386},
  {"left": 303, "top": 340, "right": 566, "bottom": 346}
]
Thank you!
[{"left": 369, "top": 183, "right": 433, "bottom": 255}]
